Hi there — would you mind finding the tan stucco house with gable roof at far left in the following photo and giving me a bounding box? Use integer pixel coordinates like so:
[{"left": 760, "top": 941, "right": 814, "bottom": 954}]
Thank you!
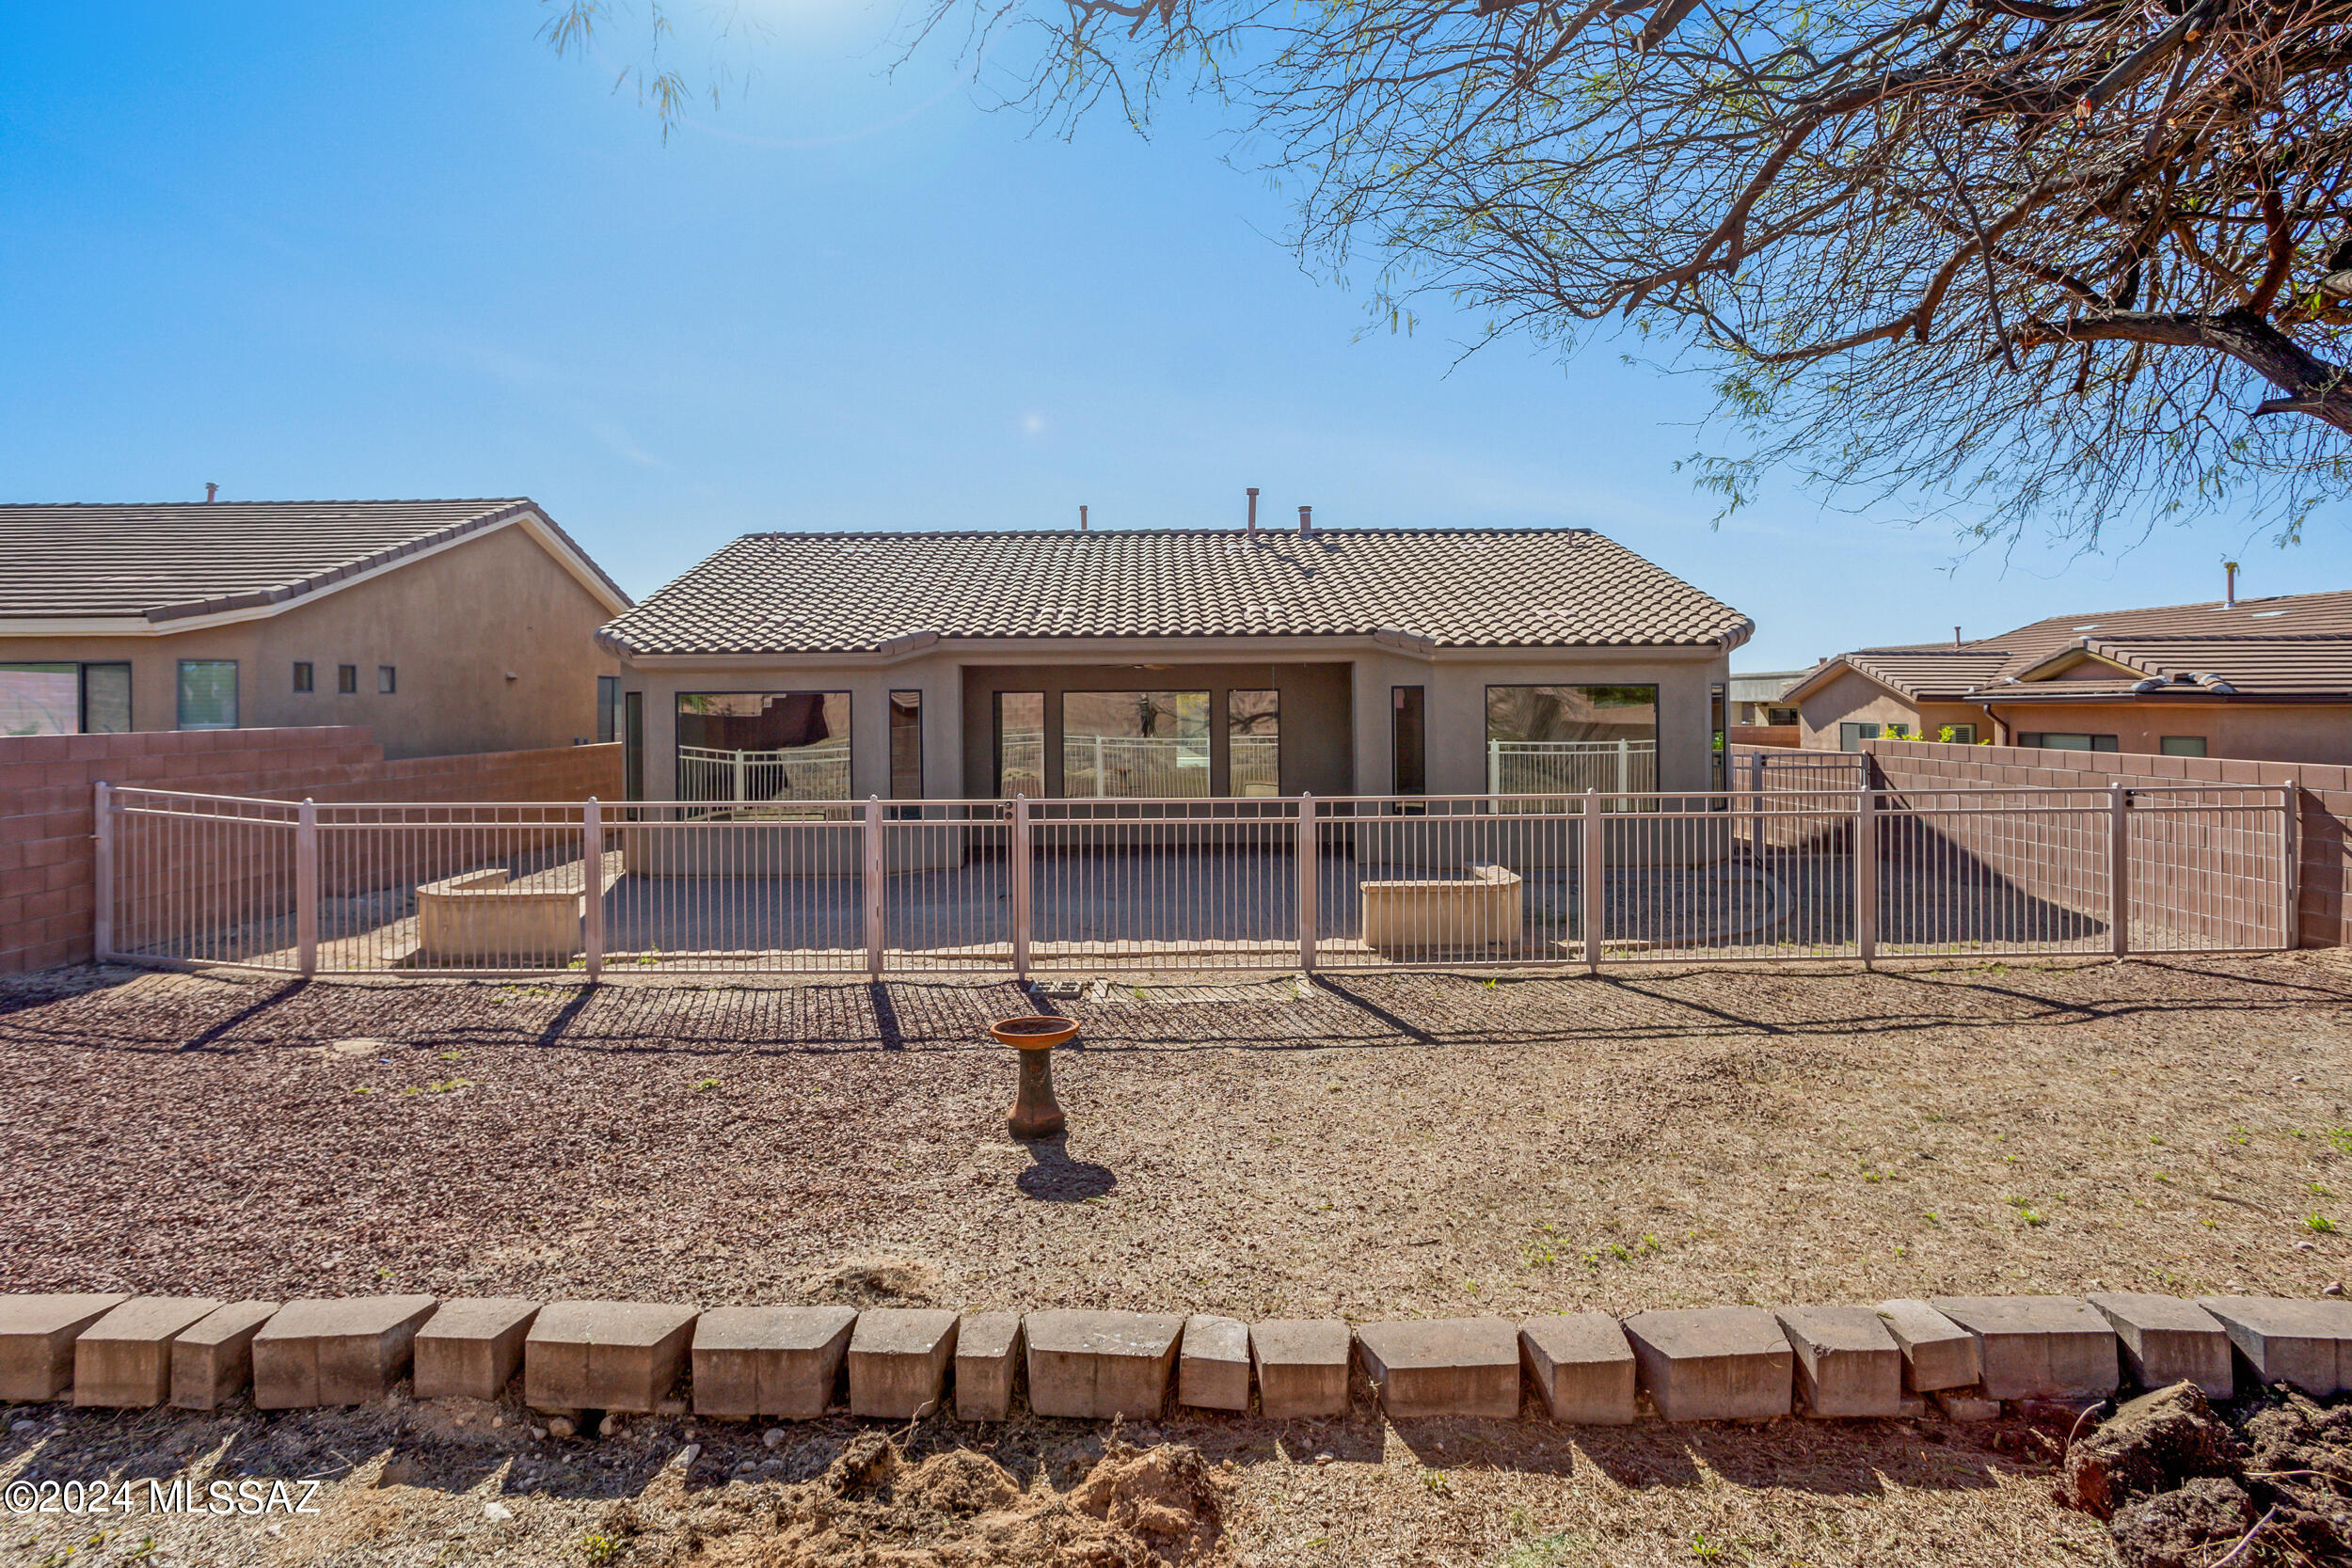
[{"left": 0, "top": 499, "right": 630, "bottom": 757}]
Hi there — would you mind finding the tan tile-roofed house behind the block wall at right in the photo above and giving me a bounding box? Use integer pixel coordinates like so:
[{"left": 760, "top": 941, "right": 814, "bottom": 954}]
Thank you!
[{"left": 1790, "top": 593, "right": 2352, "bottom": 764}]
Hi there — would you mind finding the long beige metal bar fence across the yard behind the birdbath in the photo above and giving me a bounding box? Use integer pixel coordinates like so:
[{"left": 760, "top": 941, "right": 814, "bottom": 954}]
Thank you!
[{"left": 97, "top": 785, "right": 2296, "bottom": 975}]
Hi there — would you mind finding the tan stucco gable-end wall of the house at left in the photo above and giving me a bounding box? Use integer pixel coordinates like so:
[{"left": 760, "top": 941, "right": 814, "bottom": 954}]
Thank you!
[{"left": 0, "top": 524, "right": 619, "bottom": 757}]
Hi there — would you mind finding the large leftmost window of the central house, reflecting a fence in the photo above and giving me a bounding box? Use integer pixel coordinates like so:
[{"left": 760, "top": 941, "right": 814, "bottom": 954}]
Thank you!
[{"left": 677, "top": 691, "right": 850, "bottom": 801}]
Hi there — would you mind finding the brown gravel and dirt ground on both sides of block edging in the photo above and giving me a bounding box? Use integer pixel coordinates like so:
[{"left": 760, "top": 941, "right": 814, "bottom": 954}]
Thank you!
[{"left": 0, "top": 955, "right": 2352, "bottom": 1568}]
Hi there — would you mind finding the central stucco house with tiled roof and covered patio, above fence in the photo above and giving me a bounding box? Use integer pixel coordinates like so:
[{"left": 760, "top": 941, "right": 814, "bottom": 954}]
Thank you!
[{"left": 602, "top": 529, "right": 1753, "bottom": 801}]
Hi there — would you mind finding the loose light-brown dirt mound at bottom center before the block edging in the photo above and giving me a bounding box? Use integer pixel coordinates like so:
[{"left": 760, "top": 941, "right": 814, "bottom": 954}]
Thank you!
[{"left": 607, "top": 1432, "right": 1226, "bottom": 1568}]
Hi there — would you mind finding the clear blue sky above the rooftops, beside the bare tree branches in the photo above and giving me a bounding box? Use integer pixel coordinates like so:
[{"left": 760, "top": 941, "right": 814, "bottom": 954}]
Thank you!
[{"left": 0, "top": 0, "right": 2352, "bottom": 668}]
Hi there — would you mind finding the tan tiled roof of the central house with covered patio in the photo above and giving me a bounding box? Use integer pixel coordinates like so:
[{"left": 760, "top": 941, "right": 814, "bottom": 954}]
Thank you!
[{"left": 597, "top": 529, "right": 1755, "bottom": 656}]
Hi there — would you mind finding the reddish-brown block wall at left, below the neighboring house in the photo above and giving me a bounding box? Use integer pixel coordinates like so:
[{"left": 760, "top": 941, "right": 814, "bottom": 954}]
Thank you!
[{"left": 0, "top": 724, "right": 621, "bottom": 974}]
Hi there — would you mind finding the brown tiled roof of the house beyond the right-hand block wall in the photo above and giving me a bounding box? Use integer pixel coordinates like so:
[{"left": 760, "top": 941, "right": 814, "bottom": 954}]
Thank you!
[{"left": 1790, "top": 593, "right": 2352, "bottom": 703}]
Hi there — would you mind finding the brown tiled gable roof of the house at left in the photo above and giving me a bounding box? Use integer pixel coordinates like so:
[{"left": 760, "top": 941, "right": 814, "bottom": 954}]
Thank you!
[{"left": 0, "top": 496, "right": 630, "bottom": 637}]
